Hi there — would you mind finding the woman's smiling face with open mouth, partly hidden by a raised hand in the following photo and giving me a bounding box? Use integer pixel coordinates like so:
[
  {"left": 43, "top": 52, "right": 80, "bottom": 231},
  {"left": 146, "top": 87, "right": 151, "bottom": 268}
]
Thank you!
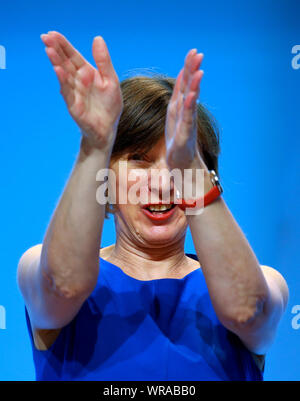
[{"left": 110, "top": 138, "right": 187, "bottom": 247}]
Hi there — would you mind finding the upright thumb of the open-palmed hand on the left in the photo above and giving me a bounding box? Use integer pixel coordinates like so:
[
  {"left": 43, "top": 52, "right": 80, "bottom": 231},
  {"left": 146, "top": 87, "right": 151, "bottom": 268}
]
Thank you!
[{"left": 92, "top": 36, "right": 116, "bottom": 79}]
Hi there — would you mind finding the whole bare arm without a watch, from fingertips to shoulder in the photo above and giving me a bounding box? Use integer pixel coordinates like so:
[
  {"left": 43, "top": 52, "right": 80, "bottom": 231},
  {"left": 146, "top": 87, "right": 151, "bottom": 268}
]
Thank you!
[{"left": 18, "top": 32, "right": 123, "bottom": 329}]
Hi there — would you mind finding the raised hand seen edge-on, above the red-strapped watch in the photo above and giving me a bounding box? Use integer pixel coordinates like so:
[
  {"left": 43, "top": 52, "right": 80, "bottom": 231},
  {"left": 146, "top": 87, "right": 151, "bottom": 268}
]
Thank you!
[{"left": 165, "top": 49, "right": 203, "bottom": 171}]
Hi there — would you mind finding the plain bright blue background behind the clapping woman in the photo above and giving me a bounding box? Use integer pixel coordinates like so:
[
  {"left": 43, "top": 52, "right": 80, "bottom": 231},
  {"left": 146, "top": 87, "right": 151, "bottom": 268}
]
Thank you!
[{"left": 0, "top": 0, "right": 300, "bottom": 380}]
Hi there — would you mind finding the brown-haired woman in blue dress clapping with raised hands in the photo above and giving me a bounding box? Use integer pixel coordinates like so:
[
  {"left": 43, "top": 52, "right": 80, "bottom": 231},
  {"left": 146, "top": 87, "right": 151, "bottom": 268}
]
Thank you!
[{"left": 18, "top": 32, "right": 288, "bottom": 380}]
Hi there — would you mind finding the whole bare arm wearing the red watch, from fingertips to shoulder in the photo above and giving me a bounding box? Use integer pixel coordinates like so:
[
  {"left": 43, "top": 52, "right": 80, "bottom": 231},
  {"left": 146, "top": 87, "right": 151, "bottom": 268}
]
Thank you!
[{"left": 166, "top": 50, "right": 288, "bottom": 353}]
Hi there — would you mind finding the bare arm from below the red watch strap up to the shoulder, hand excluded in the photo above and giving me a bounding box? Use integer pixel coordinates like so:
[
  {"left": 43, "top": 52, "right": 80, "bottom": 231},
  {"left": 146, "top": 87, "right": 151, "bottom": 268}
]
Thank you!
[{"left": 187, "top": 185, "right": 288, "bottom": 354}]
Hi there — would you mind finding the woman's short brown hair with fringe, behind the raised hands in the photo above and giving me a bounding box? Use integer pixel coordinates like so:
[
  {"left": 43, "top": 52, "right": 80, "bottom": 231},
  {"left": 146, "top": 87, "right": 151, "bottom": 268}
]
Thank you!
[{"left": 105, "top": 74, "right": 220, "bottom": 219}]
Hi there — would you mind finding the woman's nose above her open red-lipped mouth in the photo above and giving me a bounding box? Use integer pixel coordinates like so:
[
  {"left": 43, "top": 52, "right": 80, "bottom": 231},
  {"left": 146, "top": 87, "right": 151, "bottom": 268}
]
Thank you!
[{"left": 148, "top": 157, "right": 174, "bottom": 203}]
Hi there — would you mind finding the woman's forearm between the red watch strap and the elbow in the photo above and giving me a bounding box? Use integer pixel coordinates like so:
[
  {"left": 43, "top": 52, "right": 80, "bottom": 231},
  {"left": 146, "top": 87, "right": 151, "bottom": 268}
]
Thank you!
[{"left": 187, "top": 162, "right": 268, "bottom": 328}]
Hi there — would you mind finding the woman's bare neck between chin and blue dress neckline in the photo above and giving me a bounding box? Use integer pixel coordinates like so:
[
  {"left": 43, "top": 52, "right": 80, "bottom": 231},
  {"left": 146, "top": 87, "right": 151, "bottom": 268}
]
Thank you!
[{"left": 106, "top": 236, "right": 198, "bottom": 280}]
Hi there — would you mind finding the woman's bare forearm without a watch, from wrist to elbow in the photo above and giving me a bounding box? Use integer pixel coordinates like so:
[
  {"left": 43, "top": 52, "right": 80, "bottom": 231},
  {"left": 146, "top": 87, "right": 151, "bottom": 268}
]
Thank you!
[{"left": 40, "top": 141, "right": 110, "bottom": 297}]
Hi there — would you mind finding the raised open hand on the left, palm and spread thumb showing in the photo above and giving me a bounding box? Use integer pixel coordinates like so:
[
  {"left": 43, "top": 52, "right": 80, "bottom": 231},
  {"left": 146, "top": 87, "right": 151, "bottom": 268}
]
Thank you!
[{"left": 41, "top": 31, "right": 123, "bottom": 150}]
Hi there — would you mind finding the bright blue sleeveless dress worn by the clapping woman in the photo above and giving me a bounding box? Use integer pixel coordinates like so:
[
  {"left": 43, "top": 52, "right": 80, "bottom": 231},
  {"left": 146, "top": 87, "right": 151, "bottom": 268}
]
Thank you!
[{"left": 25, "top": 254, "right": 263, "bottom": 381}]
